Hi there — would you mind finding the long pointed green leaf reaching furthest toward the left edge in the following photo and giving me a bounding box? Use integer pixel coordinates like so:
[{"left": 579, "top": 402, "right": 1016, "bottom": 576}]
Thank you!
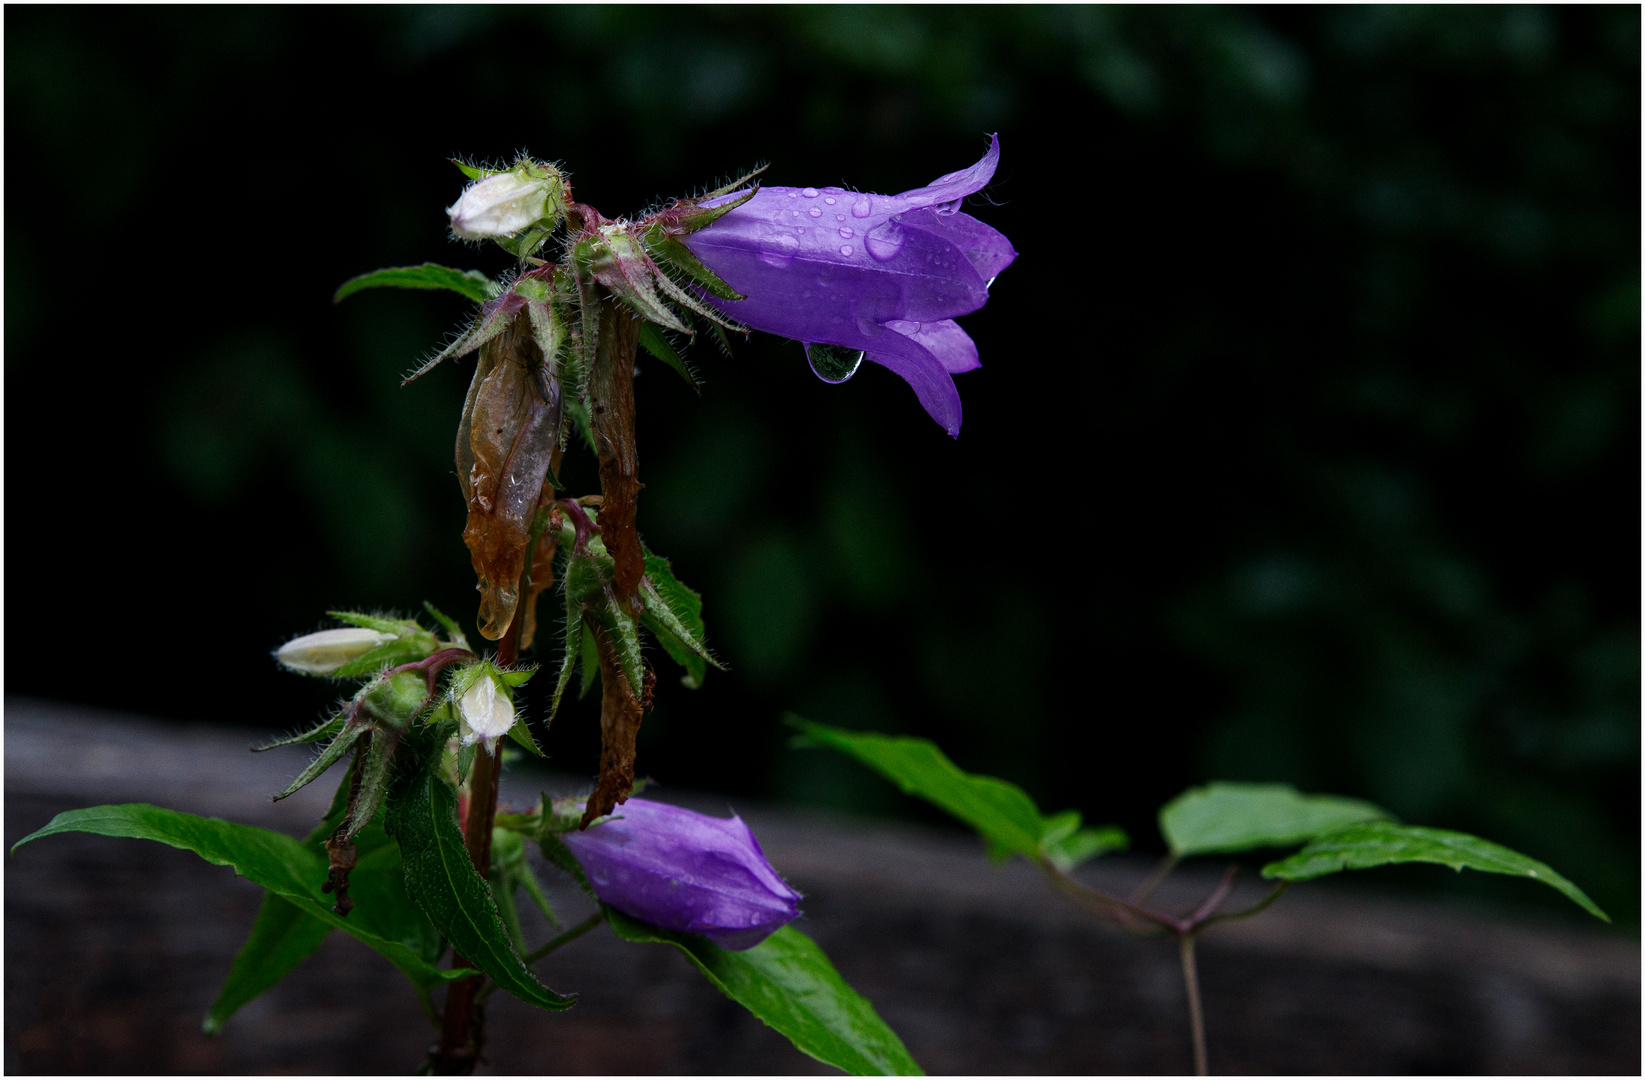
[{"left": 12, "top": 802, "right": 474, "bottom": 990}]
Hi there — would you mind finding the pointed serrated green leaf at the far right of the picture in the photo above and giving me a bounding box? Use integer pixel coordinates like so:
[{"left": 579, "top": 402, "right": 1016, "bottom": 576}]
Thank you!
[{"left": 1262, "top": 822, "right": 1610, "bottom": 922}]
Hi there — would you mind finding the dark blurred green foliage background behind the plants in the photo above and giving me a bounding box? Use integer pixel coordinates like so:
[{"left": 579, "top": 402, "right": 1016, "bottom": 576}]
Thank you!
[{"left": 5, "top": 7, "right": 1640, "bottom": 921}]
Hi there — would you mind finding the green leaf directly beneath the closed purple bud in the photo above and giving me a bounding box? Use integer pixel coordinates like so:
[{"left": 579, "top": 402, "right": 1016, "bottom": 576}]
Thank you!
[{"left": 605, "top": 907, "right": 924, "bottom": 1077}]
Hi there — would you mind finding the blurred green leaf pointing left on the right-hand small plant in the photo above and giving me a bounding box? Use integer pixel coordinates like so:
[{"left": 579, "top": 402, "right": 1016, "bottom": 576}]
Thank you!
[{"left": 785, "top": 715, "right": 1045, "bottom": 858}]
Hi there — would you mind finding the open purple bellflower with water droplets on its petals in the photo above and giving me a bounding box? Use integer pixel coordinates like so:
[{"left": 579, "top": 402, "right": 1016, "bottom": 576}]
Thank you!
[{"left": 683, "top": 136, "right": 1017, "bottom": 436}]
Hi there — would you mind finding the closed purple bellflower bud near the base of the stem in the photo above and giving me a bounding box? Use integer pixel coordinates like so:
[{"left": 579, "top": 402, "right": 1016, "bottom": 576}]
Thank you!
[{"left": 559, "top": 799, "right": 799, "bottom": 948}]
